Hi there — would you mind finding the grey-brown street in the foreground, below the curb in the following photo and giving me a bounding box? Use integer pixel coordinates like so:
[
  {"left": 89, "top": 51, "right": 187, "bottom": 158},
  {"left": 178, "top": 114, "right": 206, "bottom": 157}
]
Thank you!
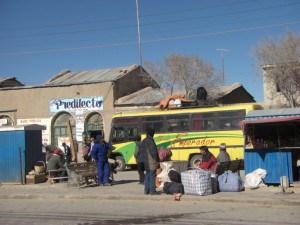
[{"left": 0, "top": 196, "right": 300, "bottom": 225}]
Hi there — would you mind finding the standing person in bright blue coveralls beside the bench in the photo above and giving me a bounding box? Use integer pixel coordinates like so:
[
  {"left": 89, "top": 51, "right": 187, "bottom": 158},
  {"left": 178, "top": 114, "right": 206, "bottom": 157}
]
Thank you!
[{"left": 91, "top": 135, "right": 115, "bottom": 186}]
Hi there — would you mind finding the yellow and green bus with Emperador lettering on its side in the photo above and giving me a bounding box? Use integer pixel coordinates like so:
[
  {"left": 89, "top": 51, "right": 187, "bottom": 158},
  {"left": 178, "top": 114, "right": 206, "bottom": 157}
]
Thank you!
[{"left": 109, "top": 103, "right": 262, "bottom": 171}]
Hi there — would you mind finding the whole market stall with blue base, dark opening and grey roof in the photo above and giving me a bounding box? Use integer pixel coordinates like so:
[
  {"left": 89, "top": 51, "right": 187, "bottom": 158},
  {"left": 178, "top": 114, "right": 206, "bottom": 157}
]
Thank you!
[{"left": 241, "top": 108, "right": 300, "bottom": 185}]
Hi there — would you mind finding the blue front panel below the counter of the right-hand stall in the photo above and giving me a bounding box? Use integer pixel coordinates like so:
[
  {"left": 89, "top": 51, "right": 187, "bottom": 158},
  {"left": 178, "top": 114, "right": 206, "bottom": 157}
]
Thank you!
[{"left": 244, "top": 149, "right": 293, "bottom": 184}]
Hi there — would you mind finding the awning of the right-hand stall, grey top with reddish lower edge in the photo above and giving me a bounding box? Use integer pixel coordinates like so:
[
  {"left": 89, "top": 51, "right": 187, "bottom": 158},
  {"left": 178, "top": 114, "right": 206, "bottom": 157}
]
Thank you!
[{"left": 240, "top": 108, "right": 300, "bottom": 132}]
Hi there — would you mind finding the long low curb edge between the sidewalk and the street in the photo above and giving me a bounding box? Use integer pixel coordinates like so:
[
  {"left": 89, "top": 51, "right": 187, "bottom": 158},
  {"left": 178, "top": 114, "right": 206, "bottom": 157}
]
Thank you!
[{"left": 0, "top": 194, "right": 300, "bottom": 206}]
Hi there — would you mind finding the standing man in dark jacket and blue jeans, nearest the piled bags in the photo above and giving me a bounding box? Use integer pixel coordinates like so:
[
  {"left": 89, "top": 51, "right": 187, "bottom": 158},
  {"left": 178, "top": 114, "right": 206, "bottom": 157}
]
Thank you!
[{"left": 142, "top": 128, "right": 159, "bottom": 195}]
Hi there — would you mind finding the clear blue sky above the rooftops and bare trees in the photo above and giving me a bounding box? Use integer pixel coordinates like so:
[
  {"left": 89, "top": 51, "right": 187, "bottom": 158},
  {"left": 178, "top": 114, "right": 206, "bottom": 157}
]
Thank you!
[{"left": 0, "top": 0, "right": 300, "bottom": 101}]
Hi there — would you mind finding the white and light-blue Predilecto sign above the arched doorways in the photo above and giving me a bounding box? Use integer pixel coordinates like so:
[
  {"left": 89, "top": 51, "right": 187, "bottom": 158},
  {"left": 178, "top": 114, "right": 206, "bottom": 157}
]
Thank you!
[{"left": 50, "top": 97, "right": 103, "bottom": 112}]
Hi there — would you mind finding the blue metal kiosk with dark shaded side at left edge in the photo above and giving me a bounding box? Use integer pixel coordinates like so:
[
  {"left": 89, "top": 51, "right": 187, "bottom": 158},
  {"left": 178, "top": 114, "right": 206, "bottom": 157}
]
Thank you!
[{"left": 0, "top": 127, "right": 45, "bottom": 184}]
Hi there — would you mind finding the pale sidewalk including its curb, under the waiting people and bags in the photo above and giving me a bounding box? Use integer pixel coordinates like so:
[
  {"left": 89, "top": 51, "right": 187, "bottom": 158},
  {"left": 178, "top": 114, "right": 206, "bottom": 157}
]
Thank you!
[{"left": 0, "top": 171, "right": 300, "bottom": 207}]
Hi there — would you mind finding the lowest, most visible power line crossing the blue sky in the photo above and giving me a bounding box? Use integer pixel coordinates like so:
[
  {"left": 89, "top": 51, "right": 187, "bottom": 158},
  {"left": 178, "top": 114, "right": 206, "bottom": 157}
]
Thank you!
[{"left": 0, "top": 20, "right": 300, "bottom": 56}]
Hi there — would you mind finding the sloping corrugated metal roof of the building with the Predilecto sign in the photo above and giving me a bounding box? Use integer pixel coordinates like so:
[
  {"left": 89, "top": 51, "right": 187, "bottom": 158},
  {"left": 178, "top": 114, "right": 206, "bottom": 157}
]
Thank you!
[{"left": 43, "top": 65, "right": 138, "bottom": 86}]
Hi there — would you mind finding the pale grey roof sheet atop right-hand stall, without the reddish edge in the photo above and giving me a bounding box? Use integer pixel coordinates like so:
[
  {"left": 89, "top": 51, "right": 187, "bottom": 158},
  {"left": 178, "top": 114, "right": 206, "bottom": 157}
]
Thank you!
[{"left": 245, "top": 108, "right": 300, "bottom": 120}]
